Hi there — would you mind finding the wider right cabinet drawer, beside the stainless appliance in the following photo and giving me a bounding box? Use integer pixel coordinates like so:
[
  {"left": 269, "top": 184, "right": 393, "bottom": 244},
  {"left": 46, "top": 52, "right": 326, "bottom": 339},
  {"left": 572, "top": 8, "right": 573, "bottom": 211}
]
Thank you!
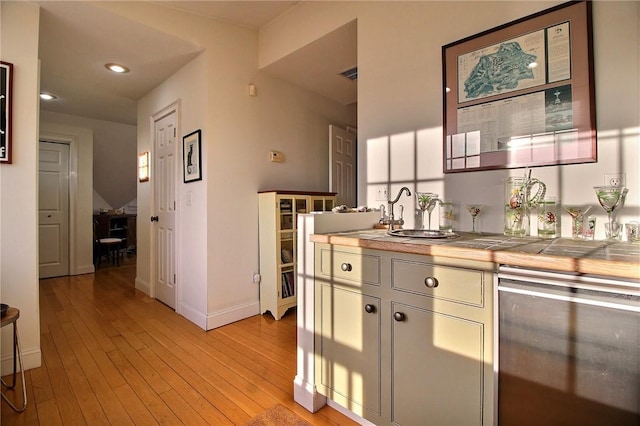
[{"left": 391, "top": 259, "right": 485, "bottom": 307}]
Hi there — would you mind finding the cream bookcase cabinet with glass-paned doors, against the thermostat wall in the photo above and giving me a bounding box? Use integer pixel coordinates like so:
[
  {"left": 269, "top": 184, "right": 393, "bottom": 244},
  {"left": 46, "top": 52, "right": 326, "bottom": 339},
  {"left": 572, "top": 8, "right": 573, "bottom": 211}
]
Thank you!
[{"left": 258, "top": 191, "right": 335, "bottom": 320}]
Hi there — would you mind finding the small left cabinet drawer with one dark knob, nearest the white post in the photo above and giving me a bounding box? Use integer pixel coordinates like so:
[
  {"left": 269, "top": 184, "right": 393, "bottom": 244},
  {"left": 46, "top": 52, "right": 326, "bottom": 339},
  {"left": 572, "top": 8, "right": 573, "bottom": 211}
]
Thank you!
[{"left": 320, "top": 249, "right": 380, "bottom": 286}]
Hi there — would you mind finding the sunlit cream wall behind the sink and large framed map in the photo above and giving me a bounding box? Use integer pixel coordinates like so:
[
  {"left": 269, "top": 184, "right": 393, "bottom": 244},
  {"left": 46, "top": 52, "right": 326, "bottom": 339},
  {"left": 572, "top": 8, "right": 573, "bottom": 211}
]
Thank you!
[{"left": 260, "top": 1, "right": 640, "bottom": 238}]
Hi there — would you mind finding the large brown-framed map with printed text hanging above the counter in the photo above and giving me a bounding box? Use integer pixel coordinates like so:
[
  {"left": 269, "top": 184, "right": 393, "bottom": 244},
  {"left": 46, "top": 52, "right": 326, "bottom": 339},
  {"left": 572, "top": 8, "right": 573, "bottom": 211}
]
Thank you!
[{"left": 442, "top": 1, "right": 597, "bottom": 173}]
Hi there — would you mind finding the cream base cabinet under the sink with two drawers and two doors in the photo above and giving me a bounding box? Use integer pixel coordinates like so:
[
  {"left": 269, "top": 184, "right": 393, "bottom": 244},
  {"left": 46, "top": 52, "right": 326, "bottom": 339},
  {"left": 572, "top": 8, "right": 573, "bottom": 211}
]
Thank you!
[{"left": 315, "top": 244, "right": 495, "bottom": 426}]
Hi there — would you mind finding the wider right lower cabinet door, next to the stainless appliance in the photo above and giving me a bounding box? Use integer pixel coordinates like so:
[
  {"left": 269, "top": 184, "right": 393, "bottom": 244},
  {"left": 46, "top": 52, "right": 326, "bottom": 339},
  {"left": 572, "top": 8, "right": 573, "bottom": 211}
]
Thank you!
[{"left": 391, "top": 303, "right": 484, "bottom": 426}]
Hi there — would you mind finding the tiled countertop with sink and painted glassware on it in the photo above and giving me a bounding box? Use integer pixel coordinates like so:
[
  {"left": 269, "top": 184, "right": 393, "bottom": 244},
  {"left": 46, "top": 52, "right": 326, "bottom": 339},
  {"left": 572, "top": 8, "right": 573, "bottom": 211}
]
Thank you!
[{"left": 311, "top": 229, "right": 640, "bottom": 280}]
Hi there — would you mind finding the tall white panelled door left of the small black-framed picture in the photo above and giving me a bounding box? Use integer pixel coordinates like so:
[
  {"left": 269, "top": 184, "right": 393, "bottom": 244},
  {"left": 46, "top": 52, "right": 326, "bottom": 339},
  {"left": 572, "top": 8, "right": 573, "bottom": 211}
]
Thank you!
[{"left": 152, "top": 111, "right": 178, "bottom": 309}]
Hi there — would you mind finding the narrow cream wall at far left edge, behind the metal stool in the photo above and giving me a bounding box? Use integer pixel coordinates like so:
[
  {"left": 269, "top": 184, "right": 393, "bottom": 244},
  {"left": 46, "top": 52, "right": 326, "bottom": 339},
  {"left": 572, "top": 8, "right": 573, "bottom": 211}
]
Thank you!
[{"left": 0, "top": 1, "right": 41, "bottom": 375}]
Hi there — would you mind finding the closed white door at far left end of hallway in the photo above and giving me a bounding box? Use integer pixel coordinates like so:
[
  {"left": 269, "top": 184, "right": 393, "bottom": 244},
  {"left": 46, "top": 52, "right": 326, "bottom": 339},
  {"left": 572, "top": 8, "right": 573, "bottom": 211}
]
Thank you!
[{"left": 38, "top": 142, "right": 69, "bottom": 278}]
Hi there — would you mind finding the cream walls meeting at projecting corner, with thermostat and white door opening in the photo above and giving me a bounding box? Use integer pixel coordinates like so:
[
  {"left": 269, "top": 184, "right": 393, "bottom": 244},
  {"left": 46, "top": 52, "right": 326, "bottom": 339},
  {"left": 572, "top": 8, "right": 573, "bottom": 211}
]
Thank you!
[{"left": 111, "top": 3, "right": 354, "bottom": 329}]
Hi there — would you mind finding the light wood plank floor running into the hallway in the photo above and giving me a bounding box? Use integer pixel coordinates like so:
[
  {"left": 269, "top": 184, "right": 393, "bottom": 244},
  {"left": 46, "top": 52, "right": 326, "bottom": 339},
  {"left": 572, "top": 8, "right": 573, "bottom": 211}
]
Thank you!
[{"left": 1, "top": 266, "right": 356, "bottom": 426}]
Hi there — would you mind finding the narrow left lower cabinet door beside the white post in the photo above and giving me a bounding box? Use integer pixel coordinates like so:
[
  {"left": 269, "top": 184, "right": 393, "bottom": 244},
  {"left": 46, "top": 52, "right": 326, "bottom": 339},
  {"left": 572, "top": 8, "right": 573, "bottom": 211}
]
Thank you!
[{"left": 316, "top": 285, "right": 380, "bottom": 417}]
